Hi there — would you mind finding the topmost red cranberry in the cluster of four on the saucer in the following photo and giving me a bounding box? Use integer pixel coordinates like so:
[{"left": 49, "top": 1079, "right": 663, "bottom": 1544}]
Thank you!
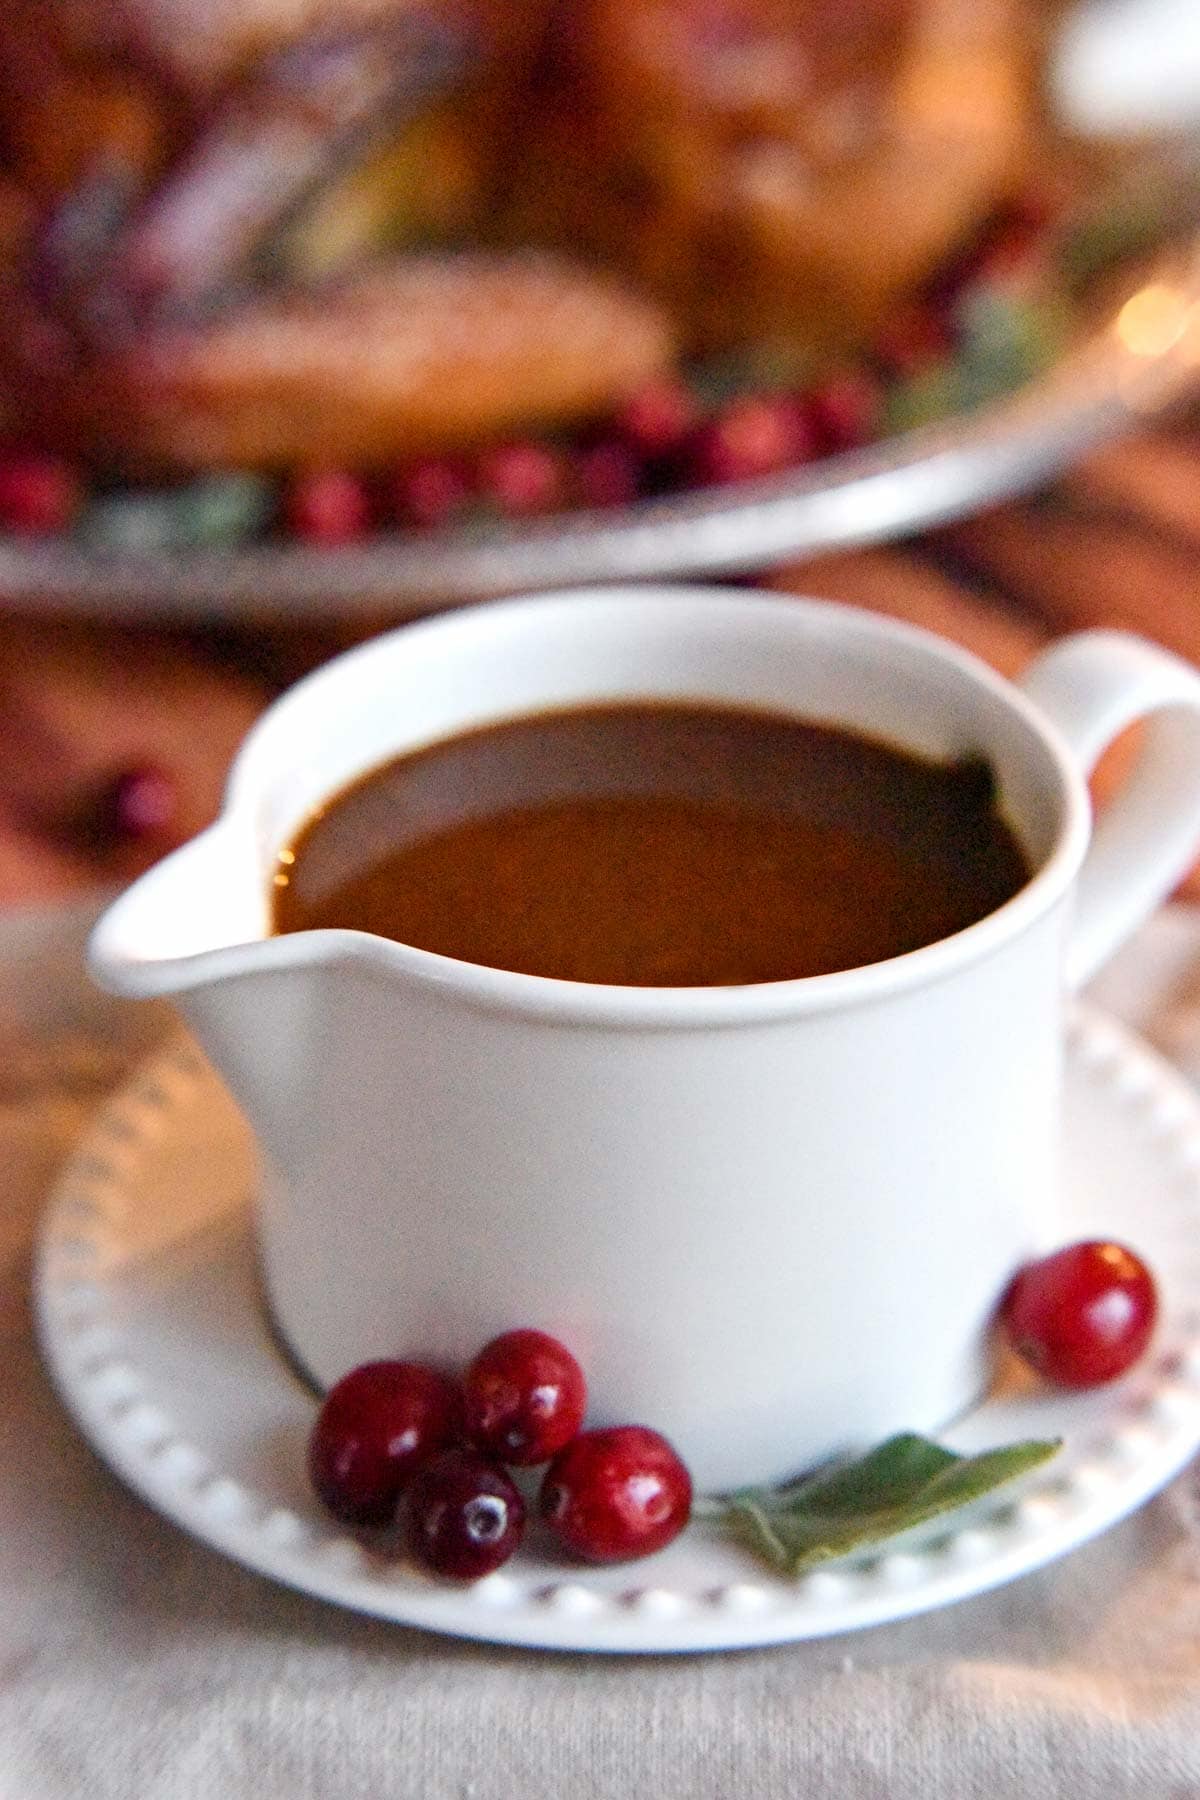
[{"left": 462, "top": 1330, "right": 588, "bottom": 1465}]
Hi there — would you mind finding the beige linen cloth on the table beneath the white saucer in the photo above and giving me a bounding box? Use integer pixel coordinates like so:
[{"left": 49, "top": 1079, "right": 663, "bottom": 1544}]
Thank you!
[{"left": 0, "top": 909, "right": 1200, "bottom": 1800}]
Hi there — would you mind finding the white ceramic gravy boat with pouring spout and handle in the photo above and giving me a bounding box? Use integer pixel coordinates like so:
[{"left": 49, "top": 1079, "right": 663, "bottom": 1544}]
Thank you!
[{"left": 90, "top": 589, "right": 1200, "bottom": 1489}]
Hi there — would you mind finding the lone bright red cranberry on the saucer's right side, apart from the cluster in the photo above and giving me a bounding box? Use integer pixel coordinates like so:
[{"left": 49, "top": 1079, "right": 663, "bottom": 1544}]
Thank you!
[{"left": 1000, "top": 1242, "right": 1159, "bottom": 1388}]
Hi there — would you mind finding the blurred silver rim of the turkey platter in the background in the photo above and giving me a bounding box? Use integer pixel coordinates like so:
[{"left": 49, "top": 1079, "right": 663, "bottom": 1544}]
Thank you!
[{"left": 0, "top": 169, "right": 1200, "bottom": 623}]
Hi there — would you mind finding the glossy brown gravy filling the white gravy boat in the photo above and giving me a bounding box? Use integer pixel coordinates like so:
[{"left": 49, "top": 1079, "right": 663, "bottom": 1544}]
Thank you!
[{"left": 273, "top": 702, "right": 1029, "bottom": 986}]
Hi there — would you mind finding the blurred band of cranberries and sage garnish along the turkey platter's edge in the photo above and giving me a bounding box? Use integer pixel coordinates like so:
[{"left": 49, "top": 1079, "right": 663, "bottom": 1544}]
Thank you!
[{"left": 0, "top": 176, "right": 1086, "bottom": 554}]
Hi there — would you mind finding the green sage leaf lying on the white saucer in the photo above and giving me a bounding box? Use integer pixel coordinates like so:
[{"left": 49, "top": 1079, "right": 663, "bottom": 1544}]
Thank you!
[{"left": 721, "top": 1431, "right": 1061, "bottom": 1575}]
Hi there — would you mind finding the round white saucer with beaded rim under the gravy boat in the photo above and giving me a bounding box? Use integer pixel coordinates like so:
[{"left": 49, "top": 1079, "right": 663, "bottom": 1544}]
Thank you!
[{"left": 36, "top": 1012, "right": 1200, "bottom": 1651}]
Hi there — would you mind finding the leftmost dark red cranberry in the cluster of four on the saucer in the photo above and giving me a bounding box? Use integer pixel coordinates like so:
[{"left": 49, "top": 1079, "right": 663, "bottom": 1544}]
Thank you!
[{"left": 308, "top": 1363, "right": 462, "bottom": 1525}]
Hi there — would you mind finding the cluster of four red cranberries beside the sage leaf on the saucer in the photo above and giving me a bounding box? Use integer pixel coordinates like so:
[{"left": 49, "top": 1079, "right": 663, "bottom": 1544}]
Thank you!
[{"left": 308, "top": 1330, "right": 691, "bottom": 1580}]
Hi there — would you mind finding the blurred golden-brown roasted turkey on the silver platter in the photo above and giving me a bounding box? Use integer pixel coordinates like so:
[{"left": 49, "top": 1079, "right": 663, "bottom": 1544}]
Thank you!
[{"left": 0, "top": 0, "right": 1045, "bottom": 470}]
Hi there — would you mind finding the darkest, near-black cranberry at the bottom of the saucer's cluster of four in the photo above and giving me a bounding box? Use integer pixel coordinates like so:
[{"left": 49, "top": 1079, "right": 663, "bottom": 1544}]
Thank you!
[{"left": 408, "top": 1449, "right": 525, "bottom": 1580}]
